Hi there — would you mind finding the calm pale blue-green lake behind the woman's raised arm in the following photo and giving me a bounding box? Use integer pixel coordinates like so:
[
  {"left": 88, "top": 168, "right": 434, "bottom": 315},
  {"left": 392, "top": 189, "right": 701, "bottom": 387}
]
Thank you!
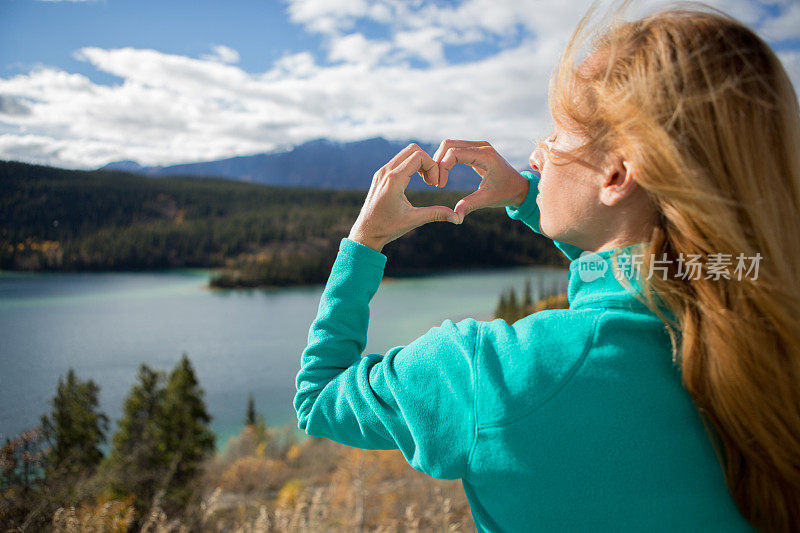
[{"left": 0, "top": 267, "right": 567, "bottom": 446}]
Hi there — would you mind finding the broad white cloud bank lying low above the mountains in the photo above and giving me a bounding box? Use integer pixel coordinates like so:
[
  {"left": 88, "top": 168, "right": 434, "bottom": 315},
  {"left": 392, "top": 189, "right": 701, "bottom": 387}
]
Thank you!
[{"left": 0, "top": 39, "right": 547, "bottom": 168}]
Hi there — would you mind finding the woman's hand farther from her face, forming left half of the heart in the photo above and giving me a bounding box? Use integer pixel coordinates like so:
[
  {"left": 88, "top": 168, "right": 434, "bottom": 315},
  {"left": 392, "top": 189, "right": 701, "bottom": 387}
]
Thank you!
[{"left": 348, "top": 144, "right": 460, "bottom": 252}]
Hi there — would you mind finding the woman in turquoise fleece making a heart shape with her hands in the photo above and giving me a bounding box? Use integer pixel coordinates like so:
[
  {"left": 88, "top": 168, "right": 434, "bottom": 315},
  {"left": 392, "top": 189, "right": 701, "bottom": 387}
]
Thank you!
[{"left": 294, "top": 5, "right": 800, "bottom": 531}]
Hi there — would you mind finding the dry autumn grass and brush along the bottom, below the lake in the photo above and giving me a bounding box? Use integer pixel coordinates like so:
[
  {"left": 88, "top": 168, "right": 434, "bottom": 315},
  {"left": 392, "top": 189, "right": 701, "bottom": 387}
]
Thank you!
[{"left": 52, "top": 427, "right": 475, "bottom": 533}]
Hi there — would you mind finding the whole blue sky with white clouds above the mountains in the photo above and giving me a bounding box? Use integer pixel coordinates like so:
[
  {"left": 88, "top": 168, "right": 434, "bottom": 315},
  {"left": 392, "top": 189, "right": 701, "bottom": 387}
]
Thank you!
[{"left": 0, "top": 0, "right": 800, "bottom": 169}]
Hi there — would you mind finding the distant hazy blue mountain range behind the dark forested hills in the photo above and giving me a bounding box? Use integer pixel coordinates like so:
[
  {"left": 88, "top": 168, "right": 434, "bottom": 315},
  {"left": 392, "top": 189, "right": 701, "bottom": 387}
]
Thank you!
[{"left": 100, "top": 137, "right": 494, "bottom": 191}]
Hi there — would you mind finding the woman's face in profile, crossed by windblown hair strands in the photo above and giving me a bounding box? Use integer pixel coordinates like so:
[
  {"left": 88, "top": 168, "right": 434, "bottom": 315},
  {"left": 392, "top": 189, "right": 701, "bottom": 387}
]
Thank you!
[{"left": 529, "top": 121, "right": 602, "bottom": 249}]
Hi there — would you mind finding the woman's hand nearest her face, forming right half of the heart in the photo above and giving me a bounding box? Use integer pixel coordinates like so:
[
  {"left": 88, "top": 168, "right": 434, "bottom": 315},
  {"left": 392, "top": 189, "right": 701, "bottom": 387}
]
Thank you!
[{"left": 433, "top": 139, "right": 529, "bottom": 224}]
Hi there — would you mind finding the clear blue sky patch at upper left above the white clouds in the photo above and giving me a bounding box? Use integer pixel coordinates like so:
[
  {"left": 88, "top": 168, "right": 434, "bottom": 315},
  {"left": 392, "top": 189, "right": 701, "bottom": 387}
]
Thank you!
[{"left": 0, "top": 0, "right": 324, "bottom": 83}]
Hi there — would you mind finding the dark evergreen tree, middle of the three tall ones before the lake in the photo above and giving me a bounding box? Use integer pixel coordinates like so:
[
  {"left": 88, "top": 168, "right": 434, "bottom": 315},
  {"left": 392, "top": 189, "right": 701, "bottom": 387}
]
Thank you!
[{"left": 109, "top": 364, "right": 169, "bottom": 511}]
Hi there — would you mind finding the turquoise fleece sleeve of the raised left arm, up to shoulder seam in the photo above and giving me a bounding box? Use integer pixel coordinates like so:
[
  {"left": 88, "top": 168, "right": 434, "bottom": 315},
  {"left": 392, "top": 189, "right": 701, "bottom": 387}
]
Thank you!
[{"left": 294, "top": 238, "right": 482, "bottom": 479}]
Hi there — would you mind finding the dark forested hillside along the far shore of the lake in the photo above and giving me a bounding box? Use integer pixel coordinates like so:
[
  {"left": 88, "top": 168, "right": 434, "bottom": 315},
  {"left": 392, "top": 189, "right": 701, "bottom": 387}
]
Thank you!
[{"left": 0, "top": 162, "right": 565, "bottom": 286}]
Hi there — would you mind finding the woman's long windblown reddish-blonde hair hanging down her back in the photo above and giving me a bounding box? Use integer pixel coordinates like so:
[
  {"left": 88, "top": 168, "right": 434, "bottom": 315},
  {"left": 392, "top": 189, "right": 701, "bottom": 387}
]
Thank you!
[{"left": 550, "top": 2, "right": 800, "bottom": 531}]
